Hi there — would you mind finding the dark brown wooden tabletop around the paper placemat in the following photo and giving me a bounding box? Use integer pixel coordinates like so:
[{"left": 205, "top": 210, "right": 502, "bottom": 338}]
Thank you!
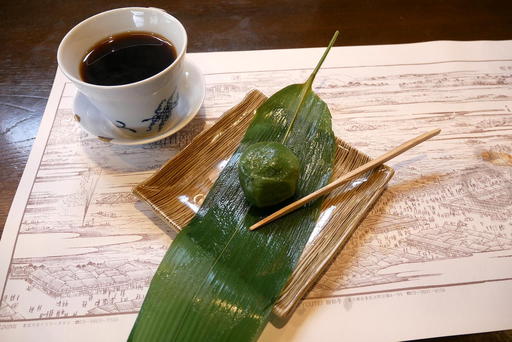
[{"left": 0, "top": 0, "right": 512, "bottom": 341}]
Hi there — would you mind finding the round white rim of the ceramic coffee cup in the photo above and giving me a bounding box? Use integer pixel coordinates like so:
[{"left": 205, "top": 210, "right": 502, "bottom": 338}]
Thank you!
[{"left": 57, "top": 7, "right": 188, "bottom": 90}]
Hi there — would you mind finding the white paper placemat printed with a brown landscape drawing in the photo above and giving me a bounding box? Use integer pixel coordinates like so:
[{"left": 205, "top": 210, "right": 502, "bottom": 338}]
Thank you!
[{"left": 0, "top": 41, "right": 512, "bottom": 341}]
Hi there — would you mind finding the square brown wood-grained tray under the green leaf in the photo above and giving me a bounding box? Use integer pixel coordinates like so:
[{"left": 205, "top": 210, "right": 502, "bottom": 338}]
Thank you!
[{"left": 133, "top": 90, "right": 394, "bottom": 320}]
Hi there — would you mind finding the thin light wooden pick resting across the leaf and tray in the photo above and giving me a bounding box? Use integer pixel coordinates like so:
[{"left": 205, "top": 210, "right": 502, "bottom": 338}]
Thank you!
[{"left": 249, "top": 129, "right": 441, "bottom": 230}]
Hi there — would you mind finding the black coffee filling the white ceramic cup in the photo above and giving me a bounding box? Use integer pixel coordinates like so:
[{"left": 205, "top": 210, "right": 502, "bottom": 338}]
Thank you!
[{"left": 80, "top": 32, "right": 177, "bottom": 86}]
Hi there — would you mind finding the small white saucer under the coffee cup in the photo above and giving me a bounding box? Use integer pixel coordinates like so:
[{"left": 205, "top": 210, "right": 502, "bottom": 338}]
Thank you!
[{"left": 73, "top": 59, "right": 205, "bottom": 145}]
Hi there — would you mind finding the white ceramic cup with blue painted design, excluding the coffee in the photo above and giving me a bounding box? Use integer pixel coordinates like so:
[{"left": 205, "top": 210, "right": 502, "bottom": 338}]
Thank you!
[{"left": 57, "top": 7, "right": 187, "bottom": 138}]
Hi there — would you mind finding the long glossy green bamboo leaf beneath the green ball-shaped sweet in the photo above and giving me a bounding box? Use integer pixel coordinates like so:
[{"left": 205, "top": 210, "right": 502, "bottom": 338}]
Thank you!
[{"left": 129, "top": 33, "right": 337, "bottom": 342}]
